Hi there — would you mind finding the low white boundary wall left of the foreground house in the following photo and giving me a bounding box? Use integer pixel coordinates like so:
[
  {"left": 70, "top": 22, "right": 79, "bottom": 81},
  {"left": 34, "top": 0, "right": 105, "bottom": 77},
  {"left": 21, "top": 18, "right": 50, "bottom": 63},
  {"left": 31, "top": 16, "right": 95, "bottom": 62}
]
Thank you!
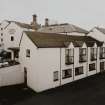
[{"left": 0, "top": 65, "right": 24, "bottom": 87}]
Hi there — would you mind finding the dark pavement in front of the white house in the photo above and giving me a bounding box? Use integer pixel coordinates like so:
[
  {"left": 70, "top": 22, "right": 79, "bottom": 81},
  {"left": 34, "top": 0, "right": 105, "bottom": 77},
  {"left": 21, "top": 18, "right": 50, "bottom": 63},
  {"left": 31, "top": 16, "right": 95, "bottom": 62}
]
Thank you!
[{"left": 0, "top": 73, "right": 105, "bottom": 105}]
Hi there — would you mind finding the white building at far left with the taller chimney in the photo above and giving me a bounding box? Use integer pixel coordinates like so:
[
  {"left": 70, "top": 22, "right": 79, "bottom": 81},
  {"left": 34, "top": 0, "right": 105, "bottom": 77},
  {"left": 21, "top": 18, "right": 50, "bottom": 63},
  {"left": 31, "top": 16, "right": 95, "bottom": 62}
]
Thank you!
[{"left": 0, "top": 15, "right": 40, "bottom": 59}]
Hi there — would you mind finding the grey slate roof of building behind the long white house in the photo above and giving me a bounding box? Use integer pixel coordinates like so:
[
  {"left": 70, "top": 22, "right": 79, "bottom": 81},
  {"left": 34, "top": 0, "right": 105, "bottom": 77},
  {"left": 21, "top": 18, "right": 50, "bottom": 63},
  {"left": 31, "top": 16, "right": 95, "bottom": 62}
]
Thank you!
[{"left": 38, "top": 23, "right": 88, "bottom": 34}]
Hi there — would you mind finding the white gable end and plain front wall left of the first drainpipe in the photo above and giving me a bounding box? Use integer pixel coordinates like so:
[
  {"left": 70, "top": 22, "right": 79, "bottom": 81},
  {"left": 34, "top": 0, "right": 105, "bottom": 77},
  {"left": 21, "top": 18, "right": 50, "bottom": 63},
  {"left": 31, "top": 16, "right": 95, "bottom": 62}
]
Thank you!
[{"left": 20, "top": 34, "right": 60, "bottom": 92}]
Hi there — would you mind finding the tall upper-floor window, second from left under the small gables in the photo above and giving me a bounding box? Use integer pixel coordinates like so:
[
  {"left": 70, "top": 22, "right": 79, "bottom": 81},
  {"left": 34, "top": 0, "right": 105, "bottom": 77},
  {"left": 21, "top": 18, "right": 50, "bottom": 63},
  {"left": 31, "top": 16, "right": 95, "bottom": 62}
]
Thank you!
[{"left": 79, "top": 48, "right": 87, "bottom": 62}]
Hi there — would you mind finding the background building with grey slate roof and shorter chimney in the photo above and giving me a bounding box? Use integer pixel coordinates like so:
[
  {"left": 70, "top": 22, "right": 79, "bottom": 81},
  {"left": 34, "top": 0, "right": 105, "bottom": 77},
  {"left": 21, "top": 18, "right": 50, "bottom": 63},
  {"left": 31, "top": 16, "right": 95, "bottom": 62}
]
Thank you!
[{"left": 38, "top": 18, "right": 88, "bottom": 36}]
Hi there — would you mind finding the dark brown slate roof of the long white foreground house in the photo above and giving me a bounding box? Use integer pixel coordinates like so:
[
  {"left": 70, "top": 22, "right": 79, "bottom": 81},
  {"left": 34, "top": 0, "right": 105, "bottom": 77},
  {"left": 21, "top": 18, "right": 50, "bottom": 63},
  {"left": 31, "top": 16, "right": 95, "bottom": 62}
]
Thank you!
[{"left": 25, "top": 31, "right": 103, "bottom": 48}]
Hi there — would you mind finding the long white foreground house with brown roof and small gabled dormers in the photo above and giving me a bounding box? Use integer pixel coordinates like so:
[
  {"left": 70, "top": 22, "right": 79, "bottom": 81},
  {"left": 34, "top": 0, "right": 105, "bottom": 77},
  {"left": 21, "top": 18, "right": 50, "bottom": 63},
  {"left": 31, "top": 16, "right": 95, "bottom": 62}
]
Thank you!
[{"left": 19, "top": 31, "right": 105, "bottom": 92}]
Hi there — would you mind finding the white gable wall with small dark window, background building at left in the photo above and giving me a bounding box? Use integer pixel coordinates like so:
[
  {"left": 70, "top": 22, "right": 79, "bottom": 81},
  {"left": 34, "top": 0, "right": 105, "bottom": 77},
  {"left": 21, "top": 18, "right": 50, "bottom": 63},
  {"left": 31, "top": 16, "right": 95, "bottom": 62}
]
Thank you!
[{"left": 4, "top": 22, "right": 23, "bottom": 49}]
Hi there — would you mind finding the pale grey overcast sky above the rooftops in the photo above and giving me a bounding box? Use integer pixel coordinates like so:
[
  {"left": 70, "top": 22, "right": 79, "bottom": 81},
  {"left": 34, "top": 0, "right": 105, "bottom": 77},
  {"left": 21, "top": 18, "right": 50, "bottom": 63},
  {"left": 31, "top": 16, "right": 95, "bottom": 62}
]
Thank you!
[{"left": 0, "top": 0, "right": 105, "bottom": 30}]
